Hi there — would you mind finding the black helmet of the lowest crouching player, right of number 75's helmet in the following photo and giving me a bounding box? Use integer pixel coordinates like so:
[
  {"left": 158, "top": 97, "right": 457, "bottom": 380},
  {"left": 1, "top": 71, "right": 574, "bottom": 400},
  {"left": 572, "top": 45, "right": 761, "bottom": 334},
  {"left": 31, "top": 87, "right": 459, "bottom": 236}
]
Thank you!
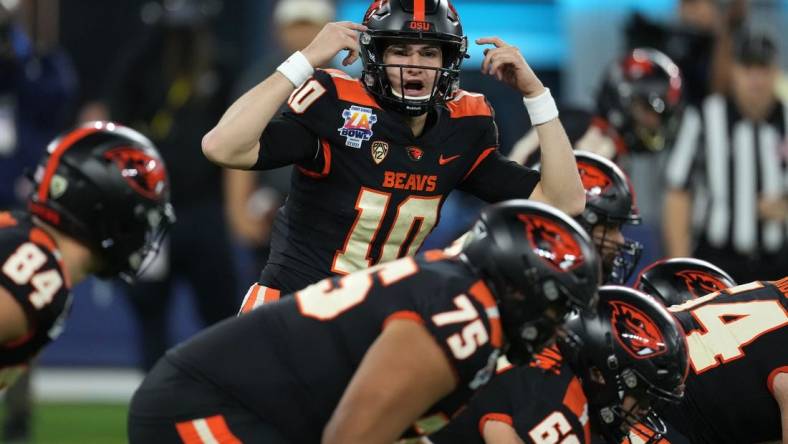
[{"left": 558, "top": 286, "right": 688, "bottom": 443}]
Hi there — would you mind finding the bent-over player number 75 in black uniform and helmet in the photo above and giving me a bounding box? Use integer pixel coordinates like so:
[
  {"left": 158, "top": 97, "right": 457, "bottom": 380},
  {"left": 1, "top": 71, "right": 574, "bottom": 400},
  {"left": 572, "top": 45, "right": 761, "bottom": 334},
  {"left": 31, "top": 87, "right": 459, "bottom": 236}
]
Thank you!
[{"left": 129, "top": 200, "right": 600, "bottom": 444}]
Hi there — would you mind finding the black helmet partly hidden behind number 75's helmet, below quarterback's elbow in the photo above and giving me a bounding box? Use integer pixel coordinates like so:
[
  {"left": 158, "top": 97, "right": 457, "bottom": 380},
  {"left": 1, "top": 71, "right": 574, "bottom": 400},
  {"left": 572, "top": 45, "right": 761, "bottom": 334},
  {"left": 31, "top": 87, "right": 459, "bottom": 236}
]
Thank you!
[{"left": 575, "top": 151, "right": 643, "bottom": 285}]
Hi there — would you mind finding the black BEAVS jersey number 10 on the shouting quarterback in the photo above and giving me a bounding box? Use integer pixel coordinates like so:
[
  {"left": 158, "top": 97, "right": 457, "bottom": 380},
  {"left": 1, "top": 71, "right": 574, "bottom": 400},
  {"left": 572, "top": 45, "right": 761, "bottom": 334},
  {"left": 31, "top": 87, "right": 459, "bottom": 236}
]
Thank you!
[{"left": 254, "top": 70, "right": 539, "bottom": 293}]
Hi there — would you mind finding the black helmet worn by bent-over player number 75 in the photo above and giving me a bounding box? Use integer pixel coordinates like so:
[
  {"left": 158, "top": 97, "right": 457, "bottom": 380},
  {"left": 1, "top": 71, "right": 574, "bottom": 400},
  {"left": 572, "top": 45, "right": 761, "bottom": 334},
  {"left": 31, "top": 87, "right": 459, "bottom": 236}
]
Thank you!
[{"left": 461, "top": 200, "right": 600, "bottom": 365}]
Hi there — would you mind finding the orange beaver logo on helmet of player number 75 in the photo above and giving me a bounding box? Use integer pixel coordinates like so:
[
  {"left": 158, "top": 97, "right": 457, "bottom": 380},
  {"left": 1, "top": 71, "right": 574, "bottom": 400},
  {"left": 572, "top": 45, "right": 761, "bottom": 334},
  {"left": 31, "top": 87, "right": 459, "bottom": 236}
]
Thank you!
[{"left": 518, "top": 215, "right": 584, "bottom": 271}]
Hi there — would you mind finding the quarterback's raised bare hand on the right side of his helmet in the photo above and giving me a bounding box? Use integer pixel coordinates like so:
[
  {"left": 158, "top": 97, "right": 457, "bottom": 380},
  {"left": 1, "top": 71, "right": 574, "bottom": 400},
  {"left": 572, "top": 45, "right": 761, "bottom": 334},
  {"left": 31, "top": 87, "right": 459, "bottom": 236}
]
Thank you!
[{"left": 476, "top": 37, "right": 544, "bottom": 97}]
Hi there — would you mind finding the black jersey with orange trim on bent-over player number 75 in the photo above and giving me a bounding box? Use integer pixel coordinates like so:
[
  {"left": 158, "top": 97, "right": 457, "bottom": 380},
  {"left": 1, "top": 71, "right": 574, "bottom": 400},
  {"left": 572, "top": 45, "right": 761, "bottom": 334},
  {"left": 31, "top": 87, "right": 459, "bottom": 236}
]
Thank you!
[{"left": 129, "top": 252, "right": 503, "bottom": 443}]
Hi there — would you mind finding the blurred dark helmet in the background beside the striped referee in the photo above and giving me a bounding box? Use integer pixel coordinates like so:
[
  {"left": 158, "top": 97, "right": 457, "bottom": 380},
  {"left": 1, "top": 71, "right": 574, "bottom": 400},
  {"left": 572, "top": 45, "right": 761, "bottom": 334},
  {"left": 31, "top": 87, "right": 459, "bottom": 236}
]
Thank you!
[{"left": 597, "top": 48, "right": 683, "bottom": 152}]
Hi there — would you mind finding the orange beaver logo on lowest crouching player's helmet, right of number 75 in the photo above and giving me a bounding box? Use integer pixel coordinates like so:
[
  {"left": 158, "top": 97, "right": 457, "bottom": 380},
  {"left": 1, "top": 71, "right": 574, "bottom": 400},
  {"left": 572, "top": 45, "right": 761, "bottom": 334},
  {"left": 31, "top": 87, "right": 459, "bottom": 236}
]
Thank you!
[{"left": 609, "top": 301, "right": 667, "bottom": 359}]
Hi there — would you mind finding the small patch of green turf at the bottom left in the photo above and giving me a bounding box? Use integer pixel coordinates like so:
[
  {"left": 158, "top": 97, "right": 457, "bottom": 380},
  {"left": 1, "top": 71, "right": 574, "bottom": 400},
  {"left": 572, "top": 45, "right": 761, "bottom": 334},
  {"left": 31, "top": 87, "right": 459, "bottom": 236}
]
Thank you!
[{"left": 0, "top": 403, "right": 127, "bottom": 444}]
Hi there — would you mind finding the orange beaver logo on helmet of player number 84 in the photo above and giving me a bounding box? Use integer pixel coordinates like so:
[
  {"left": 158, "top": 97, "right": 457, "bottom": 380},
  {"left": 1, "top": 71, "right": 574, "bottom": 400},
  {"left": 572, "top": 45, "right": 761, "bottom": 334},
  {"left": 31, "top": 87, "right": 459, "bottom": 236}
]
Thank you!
[{"left": 104, "top": 147, "right": 167, "bottom": 200}]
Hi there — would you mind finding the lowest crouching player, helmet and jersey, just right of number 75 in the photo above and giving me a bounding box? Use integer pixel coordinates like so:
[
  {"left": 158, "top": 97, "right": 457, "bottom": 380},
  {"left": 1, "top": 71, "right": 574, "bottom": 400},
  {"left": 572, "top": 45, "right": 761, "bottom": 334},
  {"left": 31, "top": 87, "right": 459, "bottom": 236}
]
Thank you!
[{"left": 424, "top": 286, "right": 687, "bottom": 444}]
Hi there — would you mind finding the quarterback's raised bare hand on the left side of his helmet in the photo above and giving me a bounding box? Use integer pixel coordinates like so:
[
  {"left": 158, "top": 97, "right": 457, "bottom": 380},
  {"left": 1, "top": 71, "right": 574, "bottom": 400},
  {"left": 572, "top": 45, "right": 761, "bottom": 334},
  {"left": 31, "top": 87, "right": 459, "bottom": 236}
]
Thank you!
[{"left": 301, "top": 22, "right": 367, "bottom": 68}]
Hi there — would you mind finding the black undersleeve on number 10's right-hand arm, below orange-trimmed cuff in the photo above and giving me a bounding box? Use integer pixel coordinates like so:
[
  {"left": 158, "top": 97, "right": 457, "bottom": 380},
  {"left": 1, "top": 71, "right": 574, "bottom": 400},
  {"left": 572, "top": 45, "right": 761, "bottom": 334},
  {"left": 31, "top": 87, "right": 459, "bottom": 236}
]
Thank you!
[{"left": 458, "top": 150, "right": 541, "bottom": 202}]
